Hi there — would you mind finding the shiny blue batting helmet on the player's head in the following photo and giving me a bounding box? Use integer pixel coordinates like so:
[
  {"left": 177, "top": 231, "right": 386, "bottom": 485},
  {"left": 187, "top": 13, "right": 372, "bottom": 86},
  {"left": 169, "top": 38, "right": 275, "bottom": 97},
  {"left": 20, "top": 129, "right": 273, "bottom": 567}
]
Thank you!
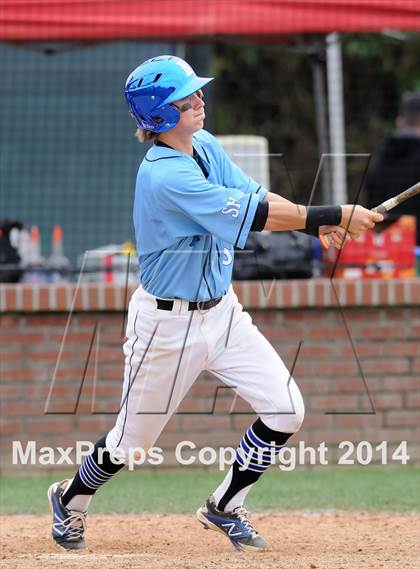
[{"left": 124, "top": 55, "right": 213, "bottom": 132}]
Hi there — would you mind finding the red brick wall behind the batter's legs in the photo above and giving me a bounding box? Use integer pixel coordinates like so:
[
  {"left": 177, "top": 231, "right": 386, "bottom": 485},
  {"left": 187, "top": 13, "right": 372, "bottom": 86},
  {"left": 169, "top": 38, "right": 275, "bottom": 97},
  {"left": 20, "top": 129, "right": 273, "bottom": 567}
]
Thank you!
[{"left": 0, "top": 279, "right": 420, "bottom": 471}]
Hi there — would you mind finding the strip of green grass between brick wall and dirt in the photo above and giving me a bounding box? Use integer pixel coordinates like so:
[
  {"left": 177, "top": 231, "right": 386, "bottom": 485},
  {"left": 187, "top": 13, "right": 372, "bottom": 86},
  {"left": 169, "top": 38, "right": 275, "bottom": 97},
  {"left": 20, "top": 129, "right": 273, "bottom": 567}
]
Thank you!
[{"left": 0, "top": 466, "right": 420, "bottom": 514}]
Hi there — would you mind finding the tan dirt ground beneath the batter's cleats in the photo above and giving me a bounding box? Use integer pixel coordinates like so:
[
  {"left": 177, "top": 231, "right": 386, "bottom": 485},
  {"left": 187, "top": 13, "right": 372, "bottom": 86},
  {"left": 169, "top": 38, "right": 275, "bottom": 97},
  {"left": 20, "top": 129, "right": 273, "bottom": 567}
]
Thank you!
[{"left": 0, "top": 512, "right": 420, "bottom": 569}]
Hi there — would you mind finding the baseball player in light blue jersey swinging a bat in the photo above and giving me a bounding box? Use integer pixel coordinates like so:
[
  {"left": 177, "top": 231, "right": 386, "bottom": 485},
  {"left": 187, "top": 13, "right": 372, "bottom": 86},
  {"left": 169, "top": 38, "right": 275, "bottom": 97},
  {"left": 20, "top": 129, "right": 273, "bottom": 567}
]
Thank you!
[{"left": 48, "top": 55, "right": 383, "bottom": 551}]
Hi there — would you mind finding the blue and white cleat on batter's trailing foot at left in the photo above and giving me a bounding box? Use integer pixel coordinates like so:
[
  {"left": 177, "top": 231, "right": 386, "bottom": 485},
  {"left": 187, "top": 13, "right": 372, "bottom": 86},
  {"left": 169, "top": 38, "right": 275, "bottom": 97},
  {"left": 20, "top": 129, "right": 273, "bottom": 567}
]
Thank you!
[{"left": 48, "top": 480, "right": 87, "bottom": 549}]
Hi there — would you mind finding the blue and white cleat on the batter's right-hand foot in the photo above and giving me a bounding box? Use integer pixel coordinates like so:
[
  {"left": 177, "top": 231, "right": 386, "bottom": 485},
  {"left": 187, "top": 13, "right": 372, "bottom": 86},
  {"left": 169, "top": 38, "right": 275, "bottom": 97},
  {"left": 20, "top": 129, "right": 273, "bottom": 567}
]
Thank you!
[{"left": 197, "top": 496, "right": 270, "bottom": 551}]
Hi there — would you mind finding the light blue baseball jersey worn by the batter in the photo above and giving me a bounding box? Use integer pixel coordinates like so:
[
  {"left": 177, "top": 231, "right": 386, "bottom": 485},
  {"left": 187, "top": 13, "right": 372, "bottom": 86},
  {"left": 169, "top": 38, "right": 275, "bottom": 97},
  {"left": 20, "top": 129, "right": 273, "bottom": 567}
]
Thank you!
[{"left": 133, "top": 130, "right": 267, "bottom": 301}]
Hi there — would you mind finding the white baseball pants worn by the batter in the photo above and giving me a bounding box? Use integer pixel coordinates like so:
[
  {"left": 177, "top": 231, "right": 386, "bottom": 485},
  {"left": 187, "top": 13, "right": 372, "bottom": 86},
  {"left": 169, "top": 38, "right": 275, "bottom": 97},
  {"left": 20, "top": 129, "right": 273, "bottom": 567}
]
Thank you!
[{"left": 106, "top": 287, "right": 304, "bottom": 453}]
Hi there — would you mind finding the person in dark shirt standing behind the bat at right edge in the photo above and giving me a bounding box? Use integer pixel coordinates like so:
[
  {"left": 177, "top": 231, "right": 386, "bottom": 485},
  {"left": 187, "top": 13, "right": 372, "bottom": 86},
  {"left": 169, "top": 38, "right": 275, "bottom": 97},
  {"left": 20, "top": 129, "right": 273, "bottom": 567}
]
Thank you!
[{"left": 365, "top": 91, "right": 420, "bottom": 245}]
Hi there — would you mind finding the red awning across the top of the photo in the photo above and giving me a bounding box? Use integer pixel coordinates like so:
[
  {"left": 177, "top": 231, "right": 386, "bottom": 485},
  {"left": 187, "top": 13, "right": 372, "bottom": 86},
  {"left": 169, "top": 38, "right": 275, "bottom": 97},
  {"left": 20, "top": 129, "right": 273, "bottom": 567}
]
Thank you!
[{"left": 0, "top": 0, "right": 420, "bottom": 41}]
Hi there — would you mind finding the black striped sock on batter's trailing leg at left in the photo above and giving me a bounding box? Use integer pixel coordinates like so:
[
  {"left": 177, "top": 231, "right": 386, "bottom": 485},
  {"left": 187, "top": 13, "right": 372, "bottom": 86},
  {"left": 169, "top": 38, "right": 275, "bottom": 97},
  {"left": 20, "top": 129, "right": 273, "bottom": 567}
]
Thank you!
[{"left": 61, "top": 436, "right": 124, "bottom": 506}]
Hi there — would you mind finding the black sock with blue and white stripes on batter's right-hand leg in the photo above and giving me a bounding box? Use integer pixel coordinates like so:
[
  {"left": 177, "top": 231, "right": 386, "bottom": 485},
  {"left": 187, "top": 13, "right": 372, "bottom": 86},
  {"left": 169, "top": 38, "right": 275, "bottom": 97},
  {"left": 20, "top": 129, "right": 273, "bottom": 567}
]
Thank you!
[{"left": 216, "top": 419, "right": 292, "bottom": 511}]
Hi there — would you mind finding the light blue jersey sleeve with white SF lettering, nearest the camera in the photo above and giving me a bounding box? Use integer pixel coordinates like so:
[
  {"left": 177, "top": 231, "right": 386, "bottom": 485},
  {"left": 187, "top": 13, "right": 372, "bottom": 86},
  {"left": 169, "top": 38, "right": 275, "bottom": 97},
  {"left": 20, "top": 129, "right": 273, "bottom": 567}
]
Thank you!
[{"left": 158, "top": 161, "right": 260, "bottom": 249}]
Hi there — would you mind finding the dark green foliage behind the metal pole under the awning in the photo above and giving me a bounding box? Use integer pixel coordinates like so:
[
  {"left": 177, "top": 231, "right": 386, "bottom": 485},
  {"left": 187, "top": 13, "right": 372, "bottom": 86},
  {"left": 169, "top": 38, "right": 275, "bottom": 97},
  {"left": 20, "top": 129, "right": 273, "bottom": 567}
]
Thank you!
[{"left": 213, "top": 32, "right": 420, "bottom": 203}]
